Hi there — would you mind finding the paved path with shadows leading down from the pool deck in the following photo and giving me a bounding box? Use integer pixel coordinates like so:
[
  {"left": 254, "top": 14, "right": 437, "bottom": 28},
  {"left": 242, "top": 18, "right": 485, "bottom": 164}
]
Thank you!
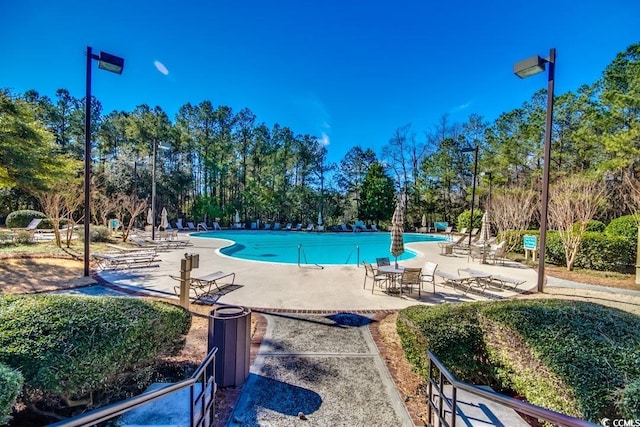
[{"left": 228, "top": 313, "right": 413, "bottom": 426}]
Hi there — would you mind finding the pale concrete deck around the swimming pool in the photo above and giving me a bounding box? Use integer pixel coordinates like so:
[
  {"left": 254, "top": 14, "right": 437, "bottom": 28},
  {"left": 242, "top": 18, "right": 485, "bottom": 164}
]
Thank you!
[{"left": 98, "top": 234, "right": 537, "bottom": 311}]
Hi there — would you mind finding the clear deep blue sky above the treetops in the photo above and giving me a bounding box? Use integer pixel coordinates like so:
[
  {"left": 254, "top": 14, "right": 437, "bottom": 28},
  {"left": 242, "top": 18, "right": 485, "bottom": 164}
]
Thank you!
[{"left": 0, "top": 0, "right": 640, "bottom": 161}]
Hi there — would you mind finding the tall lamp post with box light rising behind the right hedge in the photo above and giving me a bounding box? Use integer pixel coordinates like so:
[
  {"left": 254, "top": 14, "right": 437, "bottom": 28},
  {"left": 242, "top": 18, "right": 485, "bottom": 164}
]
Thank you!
[{"left": 513, "top": 48, "right": 556, "bottom": 292}]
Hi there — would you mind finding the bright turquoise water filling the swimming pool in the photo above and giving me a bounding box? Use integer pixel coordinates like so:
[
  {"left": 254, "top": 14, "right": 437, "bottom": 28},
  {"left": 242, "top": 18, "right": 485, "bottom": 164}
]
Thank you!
[{"left": 195, "top": 230, "right": 446, "bottom": 265}]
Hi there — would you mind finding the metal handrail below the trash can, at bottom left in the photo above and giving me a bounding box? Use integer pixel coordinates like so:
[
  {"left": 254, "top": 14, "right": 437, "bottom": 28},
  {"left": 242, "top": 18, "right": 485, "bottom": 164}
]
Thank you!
[{"left": 49, "top": 347, "right": 218, "bottom": 427}]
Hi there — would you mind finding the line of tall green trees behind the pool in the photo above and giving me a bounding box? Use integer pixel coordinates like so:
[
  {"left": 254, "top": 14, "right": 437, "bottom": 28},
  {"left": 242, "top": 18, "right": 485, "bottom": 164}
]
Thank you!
[{"left": 0, "top": 43, "right": 640, "bottom": 236}]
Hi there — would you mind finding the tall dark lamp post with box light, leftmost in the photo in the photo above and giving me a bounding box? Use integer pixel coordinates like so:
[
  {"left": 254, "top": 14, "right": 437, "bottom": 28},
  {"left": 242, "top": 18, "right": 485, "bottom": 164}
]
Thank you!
[{"left": 84, "top": 46, "right": 124, "bottom": 277}]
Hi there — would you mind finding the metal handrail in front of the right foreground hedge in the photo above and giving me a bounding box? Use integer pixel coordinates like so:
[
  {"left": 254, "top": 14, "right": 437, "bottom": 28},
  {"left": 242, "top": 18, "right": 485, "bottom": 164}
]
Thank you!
[{"left": 427, "top": 350, "right": 598, "bottom": 427}]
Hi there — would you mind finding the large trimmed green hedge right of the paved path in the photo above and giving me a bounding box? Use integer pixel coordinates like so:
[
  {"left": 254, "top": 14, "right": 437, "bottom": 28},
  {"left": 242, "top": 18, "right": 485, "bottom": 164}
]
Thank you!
[{"left": 397, "top": 300, "right": 640, "bottom": 422}]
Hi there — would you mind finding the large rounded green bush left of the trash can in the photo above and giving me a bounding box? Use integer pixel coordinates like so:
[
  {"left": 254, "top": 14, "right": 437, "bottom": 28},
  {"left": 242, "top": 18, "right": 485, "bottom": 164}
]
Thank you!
[{"left": 0, "top": 295, "right": 191, "bottom": 410}]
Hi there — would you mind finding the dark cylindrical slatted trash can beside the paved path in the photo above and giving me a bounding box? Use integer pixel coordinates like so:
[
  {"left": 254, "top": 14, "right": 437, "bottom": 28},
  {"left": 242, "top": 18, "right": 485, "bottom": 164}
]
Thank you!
[{"left": 208, "top": 306, "right": 251, "bottom": 387}]
